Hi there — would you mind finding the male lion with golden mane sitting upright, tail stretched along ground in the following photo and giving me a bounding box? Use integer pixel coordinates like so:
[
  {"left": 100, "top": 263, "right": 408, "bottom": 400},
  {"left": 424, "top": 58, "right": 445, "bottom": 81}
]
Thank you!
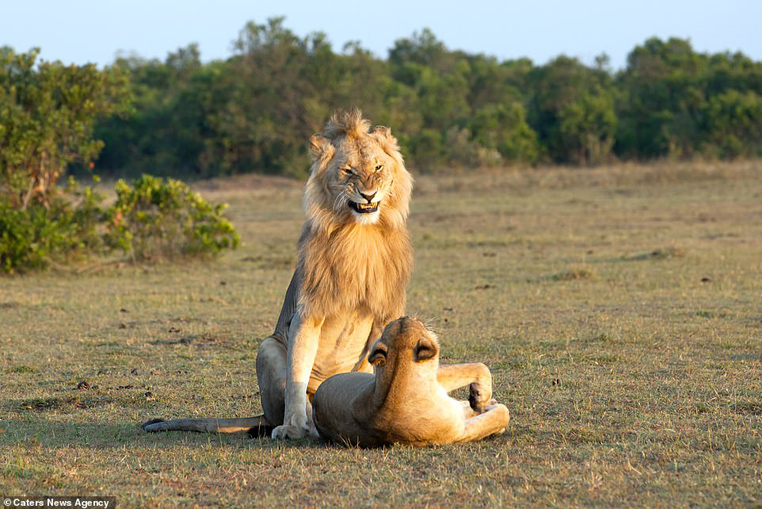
[{"left": 143, "top": 109, "right": 413, "bottom": 438}]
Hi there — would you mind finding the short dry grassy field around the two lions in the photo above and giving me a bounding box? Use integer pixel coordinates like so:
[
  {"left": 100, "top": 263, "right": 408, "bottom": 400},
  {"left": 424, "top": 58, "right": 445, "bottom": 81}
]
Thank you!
[{"left": 0, "top": 163, "right": 762, "bottom": 507}]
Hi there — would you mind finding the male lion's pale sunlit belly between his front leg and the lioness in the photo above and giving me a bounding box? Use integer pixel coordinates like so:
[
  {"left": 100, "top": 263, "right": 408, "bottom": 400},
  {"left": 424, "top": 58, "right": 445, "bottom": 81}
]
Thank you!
[{"left": 308, "top": 309, "right": 373, "bottom": 392}]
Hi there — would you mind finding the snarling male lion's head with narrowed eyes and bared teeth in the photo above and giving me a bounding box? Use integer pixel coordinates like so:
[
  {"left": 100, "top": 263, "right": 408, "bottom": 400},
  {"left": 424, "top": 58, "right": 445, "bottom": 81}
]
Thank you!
[{"left": 304, "top": 109, "right": 413, "bottom": 227}]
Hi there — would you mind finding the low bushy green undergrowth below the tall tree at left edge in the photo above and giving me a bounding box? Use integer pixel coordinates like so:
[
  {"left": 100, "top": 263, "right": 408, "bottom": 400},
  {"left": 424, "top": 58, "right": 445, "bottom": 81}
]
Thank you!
[{"left": 0, "top": 175, "right": 239, "bottom": 274}]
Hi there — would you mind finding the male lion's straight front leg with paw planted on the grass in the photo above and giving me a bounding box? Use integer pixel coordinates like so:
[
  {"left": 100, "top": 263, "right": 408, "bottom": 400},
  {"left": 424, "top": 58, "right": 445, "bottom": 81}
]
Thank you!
[{"left": 272, "top": 315, "right": 324, "bottom": 439}]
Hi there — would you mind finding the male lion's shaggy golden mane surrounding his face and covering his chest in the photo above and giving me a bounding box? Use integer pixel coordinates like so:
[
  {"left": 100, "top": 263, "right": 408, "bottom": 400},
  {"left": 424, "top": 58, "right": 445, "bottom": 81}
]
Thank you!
[{"left": 298, "top": 110, "right": 413, "bottom": 323}]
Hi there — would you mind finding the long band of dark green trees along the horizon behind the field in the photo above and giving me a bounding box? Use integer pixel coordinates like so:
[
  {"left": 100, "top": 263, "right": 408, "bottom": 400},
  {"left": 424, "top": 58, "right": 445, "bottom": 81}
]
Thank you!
[{"left": 20, "top": 18, "right": 762, "bottom": 177}]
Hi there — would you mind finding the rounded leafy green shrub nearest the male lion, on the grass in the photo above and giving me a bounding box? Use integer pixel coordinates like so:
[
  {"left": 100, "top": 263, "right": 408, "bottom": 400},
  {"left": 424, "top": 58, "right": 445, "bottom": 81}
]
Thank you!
[{"left": 106, "top": 175, "right": 240, "bottom": 260}]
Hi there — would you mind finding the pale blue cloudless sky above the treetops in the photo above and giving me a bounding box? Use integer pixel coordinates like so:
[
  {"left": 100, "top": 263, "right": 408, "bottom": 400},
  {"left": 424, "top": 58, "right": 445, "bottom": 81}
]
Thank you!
[{"left": 0, "top": 0, "right": 762, "bottom": 68}]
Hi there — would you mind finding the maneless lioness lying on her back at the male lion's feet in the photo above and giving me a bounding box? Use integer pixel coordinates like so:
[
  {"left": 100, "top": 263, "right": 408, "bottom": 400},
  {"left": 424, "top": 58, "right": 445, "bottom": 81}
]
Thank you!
[{"left": 312, "top": 317, "right": 510, "bottom": 447}]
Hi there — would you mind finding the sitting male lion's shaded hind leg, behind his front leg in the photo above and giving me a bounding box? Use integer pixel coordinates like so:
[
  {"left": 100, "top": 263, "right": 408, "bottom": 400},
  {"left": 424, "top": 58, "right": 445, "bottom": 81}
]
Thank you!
[{"left": 257, "top": 337, "right": 286, "bottom": 426}]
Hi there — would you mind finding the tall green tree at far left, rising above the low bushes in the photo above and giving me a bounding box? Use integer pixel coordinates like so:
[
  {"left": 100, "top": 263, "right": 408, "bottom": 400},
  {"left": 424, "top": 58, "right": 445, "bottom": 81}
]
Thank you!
[{"left": 0, "top": 47, "right": 128, "bottom": 210}]
